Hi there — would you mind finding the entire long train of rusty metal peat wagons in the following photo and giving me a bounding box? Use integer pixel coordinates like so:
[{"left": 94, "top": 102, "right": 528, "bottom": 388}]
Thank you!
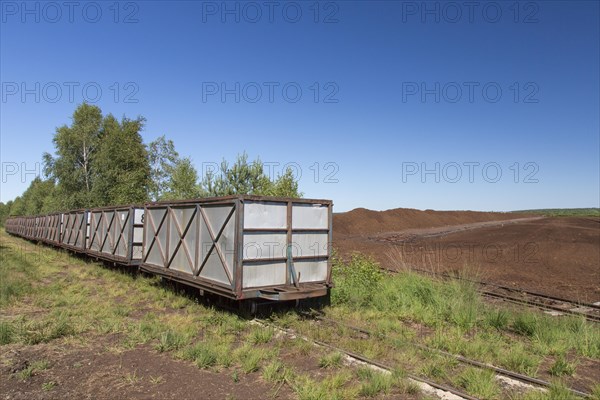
[{"left": 5, "top": 195, "right": 333, "bottom": 307}]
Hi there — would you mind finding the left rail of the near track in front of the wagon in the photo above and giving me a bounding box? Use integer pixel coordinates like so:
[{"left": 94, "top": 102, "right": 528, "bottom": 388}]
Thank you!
[{"left": 254, "top": 318, "right": 480, "bottom": 400}]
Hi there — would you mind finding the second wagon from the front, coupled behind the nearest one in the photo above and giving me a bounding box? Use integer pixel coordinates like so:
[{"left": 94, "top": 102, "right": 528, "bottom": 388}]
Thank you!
[{"left": 86, "top": 206, "right": 144, "bottom": 266}]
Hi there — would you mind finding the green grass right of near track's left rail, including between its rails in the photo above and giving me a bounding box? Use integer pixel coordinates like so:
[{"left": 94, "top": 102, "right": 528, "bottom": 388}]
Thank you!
[{"left": 296, "top": 254, "right": 600, "bottom": 397}]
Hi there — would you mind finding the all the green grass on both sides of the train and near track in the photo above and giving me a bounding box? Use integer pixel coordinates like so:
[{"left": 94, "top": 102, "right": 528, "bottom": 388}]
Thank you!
[{"left": 0, "top": 231, "right": 600, "bottom": 399}]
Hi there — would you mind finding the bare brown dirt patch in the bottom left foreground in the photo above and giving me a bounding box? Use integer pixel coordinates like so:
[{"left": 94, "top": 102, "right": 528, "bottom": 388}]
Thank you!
[{"left": 0, "top": 336, "right": 294, "bottom": 400}]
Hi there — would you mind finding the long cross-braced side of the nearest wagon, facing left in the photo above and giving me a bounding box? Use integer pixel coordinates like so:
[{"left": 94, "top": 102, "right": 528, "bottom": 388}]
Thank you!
[{"left": 141, "top": 198, "right": 239, "bottom": 298}]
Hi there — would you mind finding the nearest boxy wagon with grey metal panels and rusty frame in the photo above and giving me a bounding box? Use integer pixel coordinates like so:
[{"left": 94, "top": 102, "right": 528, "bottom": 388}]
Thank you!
[{"left": 140, "top": 195, "right": 333, "bottom": 301}]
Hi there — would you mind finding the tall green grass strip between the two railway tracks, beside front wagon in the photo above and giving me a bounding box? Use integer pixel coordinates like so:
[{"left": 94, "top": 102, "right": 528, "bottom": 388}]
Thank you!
[{"left": 332, "top": 255, "right": 600, "bottom": 358}]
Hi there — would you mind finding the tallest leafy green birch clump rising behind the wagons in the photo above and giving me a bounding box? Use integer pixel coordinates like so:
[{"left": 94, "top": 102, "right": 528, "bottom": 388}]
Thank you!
[{"left": 38, "top": 103, "right": 151, "bottom": 209}]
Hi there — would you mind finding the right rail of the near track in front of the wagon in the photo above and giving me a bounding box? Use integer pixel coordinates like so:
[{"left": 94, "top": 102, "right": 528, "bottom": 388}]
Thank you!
[{"left": 299, "top": 312, "right": 592, "bottom": 398}]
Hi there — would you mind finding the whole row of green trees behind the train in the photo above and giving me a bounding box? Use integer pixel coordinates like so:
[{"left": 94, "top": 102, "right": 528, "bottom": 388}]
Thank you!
[{"left": 0, "top": 103, "right": 302, "bottom": 225}]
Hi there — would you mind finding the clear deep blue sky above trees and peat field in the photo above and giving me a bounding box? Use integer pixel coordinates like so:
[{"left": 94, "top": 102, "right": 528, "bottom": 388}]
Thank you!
[{"left": 0, "top": 1, "right": 600, "bottom": 211}]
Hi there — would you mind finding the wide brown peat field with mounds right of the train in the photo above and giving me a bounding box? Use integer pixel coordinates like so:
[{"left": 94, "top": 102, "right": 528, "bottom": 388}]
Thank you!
[{"left": 333, "top": 209, "right": 600, "bottom": 302}]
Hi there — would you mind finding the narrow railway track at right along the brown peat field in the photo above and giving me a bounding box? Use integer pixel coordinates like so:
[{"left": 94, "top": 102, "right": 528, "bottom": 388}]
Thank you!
[{"left": 384, "top": 268, "right": 600, "bottom": 322}]
